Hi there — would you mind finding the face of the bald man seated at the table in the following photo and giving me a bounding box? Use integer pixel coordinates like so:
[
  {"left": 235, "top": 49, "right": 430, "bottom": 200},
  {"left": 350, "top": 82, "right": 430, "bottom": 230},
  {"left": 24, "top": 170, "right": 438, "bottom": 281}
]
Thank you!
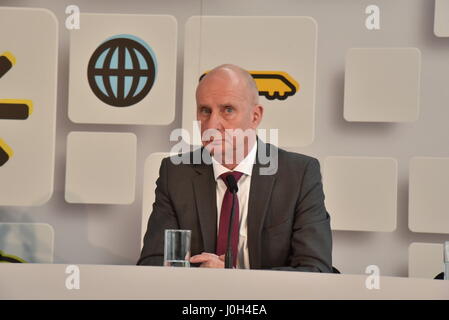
[{"left": 196, "top": 71, "right": 261, "bottom": 159}]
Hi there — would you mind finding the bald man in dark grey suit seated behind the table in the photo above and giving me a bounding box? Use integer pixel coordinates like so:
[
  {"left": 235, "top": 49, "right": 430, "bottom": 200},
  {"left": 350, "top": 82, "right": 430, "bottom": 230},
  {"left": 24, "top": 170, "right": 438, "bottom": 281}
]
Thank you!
[{"left": 137, "top": 65, "right": 332, "bottom": 272}]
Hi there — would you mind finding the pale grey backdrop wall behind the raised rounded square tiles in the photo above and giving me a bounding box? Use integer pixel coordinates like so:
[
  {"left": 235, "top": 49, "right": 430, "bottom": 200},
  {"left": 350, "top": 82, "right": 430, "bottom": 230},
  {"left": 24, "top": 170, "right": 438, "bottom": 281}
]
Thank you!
[{"left": 0, "top": 0, "right": 449, "bottom": 276}]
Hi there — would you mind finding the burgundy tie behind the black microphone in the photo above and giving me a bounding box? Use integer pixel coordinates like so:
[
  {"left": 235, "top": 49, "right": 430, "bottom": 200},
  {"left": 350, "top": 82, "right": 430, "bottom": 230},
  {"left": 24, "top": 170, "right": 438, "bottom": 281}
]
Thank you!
[{"left": 217, "top": 171, "right": 243, "bottom": 267}]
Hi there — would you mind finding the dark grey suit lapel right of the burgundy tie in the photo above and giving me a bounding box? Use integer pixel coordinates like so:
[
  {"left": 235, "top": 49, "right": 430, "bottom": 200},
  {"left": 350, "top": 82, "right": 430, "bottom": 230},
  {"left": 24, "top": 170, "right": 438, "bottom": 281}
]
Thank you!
[{"left": 247, "top": 139, "right": 277, "bottom": 269}]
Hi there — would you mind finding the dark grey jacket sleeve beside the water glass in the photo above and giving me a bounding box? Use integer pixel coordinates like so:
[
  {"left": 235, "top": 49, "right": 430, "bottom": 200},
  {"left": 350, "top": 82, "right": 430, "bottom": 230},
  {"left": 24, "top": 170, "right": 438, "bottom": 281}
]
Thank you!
[{"left": 137, "top": 158, "right": 179, "bottom": 266}]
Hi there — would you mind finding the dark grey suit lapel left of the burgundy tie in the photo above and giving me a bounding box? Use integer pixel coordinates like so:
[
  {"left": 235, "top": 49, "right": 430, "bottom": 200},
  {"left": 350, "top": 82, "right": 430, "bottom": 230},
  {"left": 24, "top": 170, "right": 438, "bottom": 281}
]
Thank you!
[{"left": 192, "top": 151, "right": 217, "bottom": 253}]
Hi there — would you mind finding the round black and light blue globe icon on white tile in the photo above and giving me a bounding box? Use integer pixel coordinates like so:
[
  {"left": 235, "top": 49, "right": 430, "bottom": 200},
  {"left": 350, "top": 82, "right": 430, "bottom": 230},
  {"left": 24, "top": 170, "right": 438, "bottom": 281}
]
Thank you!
[{"left": 87, "top": 34, "right": 157, "bottom": 107}]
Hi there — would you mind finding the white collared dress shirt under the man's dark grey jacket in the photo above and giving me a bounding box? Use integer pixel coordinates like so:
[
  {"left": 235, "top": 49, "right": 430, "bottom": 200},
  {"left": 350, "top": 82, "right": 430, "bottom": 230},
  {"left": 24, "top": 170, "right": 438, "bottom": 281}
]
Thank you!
[{"left": 212, "top": 142, "right": 257, "bottom": 269}]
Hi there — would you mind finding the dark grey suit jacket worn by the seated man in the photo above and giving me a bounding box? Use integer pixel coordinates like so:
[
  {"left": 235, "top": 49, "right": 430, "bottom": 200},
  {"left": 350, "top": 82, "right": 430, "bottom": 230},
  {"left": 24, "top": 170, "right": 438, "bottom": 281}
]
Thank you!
[{"left": 137, "top": 139, "right": 332, "bottom": 272}]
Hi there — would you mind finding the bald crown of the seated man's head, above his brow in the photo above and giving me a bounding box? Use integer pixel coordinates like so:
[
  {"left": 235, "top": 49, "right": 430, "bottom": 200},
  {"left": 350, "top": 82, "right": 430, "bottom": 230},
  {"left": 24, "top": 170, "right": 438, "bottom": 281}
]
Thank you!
[{"left": 197, "top": 64, "right": 259, "bottom": 105}]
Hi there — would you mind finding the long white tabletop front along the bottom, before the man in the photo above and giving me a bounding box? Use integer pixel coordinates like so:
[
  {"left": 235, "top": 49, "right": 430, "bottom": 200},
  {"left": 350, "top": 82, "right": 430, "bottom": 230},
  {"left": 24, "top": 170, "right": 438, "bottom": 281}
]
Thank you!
[{"left": 0, "top": 263, "right": 449, "bottom": 300}]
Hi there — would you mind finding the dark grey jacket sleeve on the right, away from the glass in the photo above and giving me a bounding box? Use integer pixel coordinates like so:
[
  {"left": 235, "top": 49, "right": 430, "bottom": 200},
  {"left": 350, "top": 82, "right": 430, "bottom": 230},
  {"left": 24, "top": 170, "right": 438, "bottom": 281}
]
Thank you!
[{"left": 275, "top": 158, "right": 332, "bottom": 273}]
